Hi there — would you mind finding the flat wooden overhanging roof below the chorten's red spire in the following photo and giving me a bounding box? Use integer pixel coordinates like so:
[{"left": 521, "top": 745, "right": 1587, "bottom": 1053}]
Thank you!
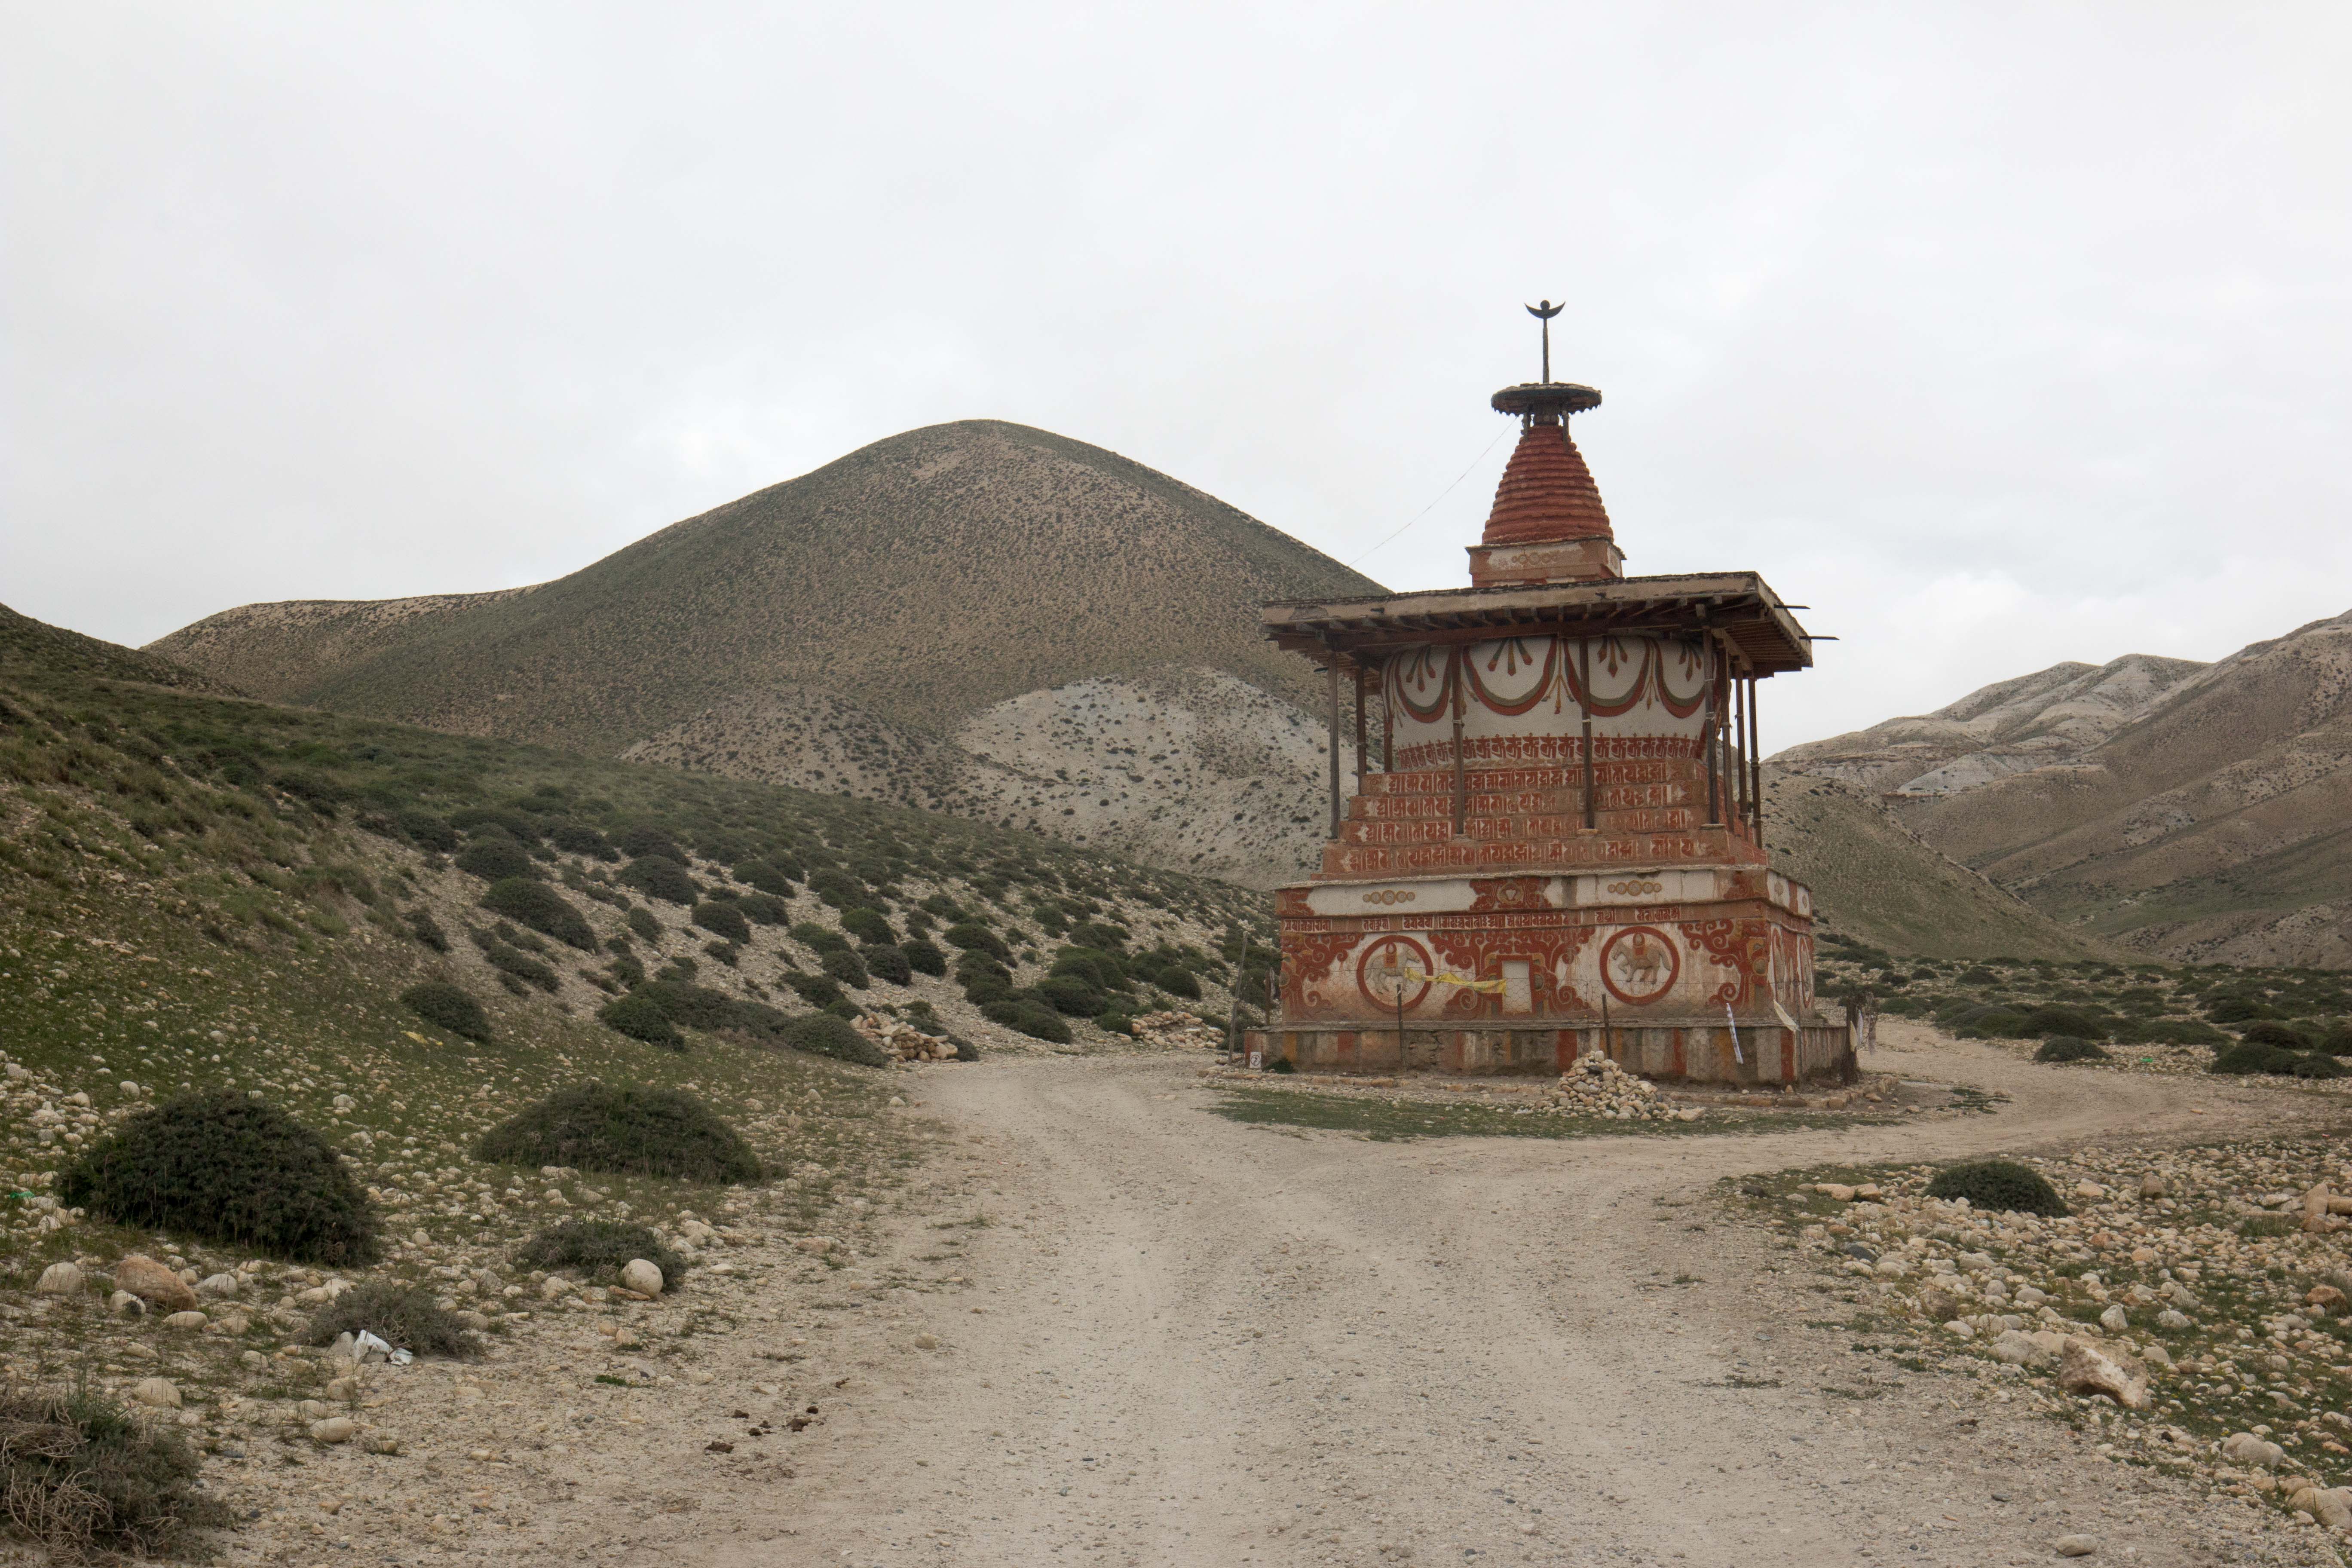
[{"left": 1263, "top": 571, "right": 1813, "bottom": 675}]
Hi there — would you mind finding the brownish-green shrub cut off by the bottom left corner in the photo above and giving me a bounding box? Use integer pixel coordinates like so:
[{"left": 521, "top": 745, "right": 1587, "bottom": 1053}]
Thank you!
[{"left": 0, "top": 1384, "right": 235, "bottom": 1561}]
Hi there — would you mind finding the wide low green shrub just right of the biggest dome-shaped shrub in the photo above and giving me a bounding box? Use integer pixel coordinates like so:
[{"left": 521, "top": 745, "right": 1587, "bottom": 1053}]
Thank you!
[{"left": 473, "top": 1081, "right": 760, "bottom": 1185}]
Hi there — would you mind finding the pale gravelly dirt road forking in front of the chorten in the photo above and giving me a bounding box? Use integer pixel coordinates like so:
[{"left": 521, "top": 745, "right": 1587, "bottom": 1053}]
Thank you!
[{"left": 748, "top": 1037, "right": 2333, "bottom": 1568}]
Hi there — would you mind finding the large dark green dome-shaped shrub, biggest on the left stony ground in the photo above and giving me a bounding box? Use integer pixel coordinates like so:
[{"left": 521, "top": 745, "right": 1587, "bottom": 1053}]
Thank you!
[{"left": 56, "top": 1088, "right": 377, "bottom": 1267}]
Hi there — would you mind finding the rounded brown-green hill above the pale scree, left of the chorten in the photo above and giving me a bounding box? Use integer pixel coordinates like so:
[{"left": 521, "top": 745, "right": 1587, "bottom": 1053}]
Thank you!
[{"left": 153, "top": 421, "right": 1378, "bottom": 755}]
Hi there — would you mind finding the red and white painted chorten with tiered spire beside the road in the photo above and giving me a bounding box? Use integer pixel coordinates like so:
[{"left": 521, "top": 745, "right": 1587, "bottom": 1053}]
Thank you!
[{"left": 1251, "top": 312, "right": 1853, "bottom": 1084}]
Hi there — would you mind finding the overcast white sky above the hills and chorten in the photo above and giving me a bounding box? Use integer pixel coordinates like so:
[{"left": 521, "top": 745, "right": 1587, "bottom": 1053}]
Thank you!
[{"left": 0, "top": 0, "right": 2352, "bottom": 750}]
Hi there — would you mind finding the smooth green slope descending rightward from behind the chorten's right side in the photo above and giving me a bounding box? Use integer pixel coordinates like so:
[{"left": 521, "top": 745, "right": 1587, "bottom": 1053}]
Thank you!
[{"left": 1764, "top": 766, "right": 2114, "bottom": 959}]
